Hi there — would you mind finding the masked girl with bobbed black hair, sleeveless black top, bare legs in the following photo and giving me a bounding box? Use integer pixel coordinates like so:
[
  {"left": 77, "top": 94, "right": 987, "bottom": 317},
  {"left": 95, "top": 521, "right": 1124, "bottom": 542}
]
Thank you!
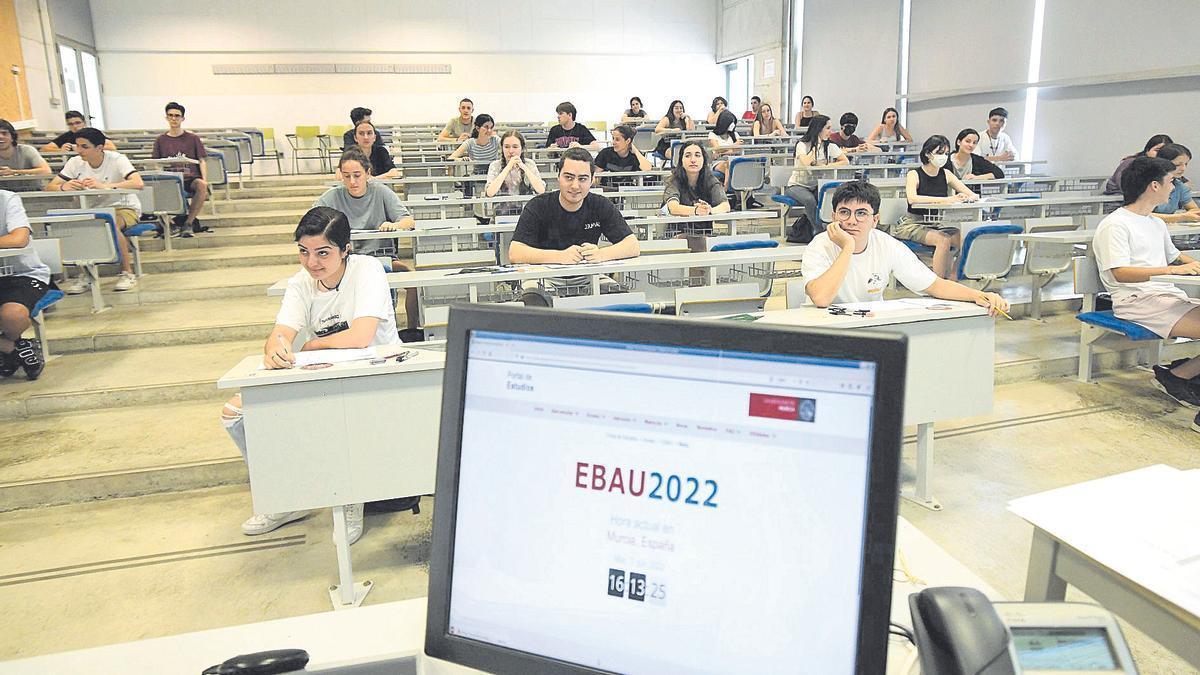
[{"left": 892, "top": 135, "right": 979, "bottom": 279}]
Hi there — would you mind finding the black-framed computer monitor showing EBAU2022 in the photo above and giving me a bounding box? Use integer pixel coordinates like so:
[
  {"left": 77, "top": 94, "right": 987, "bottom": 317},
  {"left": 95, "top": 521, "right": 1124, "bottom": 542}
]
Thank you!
[{"left": 425, "top": 306, "right": 906, "bottom": 674}]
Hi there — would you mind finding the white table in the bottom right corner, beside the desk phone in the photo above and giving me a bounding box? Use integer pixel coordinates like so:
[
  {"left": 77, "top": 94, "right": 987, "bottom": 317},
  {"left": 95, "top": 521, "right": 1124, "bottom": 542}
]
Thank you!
[{"left": 1008, "top": 465, "right": 1200, "bottom": 668}]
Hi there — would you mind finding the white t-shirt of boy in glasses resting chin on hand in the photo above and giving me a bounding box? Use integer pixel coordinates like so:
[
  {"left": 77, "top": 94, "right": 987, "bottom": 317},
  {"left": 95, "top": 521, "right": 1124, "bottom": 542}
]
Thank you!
[{"left": 800, "top": 229, "right": 937, "bottom": 303}]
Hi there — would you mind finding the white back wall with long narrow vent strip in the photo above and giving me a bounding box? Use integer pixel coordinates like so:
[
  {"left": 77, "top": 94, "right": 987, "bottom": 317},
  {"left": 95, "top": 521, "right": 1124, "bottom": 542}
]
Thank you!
[{"left": 91, "top": 0, "right": 724, "bottom": 130}]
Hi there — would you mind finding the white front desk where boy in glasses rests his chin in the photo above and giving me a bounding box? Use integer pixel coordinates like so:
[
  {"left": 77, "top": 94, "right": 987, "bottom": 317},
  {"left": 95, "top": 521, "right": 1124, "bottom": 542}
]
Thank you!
[{"left": 757, "top": 298, "right": 996, "bottom": 510}]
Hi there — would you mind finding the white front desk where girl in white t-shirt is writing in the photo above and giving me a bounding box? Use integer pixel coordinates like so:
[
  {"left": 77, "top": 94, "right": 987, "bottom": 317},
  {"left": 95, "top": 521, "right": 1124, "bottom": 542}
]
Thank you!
[{"left": 217, "top": 345, "right": 445, "bottom": 609}]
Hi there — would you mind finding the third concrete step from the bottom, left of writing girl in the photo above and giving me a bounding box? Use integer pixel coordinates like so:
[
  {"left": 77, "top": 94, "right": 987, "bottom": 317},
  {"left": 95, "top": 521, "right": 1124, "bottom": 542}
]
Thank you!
[{"left": 46, "top": 295, "right": 280, "bottom": 354}]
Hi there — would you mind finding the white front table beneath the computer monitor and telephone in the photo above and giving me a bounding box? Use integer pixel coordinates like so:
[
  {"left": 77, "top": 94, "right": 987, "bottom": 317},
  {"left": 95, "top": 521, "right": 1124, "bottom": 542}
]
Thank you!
[{"left": 0, "top": 518, "right": 1001, "bottom": 675}]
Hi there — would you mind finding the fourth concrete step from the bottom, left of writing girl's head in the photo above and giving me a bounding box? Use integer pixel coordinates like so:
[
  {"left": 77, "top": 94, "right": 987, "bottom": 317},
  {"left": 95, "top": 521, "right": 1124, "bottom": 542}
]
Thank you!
[{"left": 54, "top": 263, "right": 299, "bottom": 307}]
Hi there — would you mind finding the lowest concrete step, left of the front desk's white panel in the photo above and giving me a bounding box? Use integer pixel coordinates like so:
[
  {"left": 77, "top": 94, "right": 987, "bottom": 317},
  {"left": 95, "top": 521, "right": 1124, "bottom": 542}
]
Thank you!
[{"left": 0, "top": 400, "right": 247, "bottom": 512}]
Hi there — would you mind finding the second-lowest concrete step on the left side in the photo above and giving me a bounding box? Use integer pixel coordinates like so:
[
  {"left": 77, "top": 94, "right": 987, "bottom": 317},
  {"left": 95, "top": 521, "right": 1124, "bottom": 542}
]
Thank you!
[{"left": 0, "top": 338, "right": 263, "bottom": 417}]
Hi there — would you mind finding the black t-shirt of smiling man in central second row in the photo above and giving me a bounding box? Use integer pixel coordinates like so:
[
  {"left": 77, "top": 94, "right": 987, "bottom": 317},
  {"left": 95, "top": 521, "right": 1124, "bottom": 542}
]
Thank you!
[{"left": 512, "top": 190, "right": 634, "bottom": 251}]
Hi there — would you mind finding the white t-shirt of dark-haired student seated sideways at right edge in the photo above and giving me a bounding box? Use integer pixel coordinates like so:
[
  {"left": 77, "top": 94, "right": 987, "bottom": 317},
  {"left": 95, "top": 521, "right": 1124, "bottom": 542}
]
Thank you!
[{"left": 1092, "top": 208, "right": 1187, "bottom": 299}]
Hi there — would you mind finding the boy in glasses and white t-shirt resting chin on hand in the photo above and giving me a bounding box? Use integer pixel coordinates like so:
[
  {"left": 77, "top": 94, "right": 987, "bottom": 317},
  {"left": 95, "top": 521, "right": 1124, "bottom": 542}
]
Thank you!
[{"left": 800, "top": 180, "right": 1008, "bottom": 316}]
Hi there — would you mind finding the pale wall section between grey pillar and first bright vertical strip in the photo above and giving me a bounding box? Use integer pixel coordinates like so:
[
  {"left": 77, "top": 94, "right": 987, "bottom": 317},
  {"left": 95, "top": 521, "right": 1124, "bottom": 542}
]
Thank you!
[{"left": 792, "top": 0, "right": 900, "bottom": 130}]
